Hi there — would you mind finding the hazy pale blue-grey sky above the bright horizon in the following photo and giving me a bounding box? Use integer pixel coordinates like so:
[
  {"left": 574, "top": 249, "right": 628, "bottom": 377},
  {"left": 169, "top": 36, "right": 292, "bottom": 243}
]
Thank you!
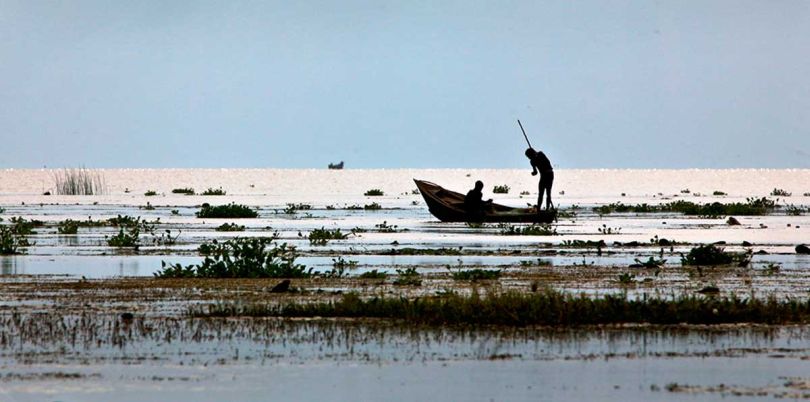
[{"left": 0, "top": 0, "right": 810, "bottom": 168}]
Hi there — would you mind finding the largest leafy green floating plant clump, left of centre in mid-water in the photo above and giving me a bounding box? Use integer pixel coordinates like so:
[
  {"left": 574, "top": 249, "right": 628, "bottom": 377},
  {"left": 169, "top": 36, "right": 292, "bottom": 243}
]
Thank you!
[{"left": 155, "top": 236, "right": 312, "bottom": 278}]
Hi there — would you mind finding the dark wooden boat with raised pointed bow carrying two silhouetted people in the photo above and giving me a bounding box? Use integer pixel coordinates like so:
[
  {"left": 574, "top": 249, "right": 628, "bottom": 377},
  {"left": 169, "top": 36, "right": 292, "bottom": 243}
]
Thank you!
[{"left": 413, "top": 179, "right": 557, "bottom": 223}]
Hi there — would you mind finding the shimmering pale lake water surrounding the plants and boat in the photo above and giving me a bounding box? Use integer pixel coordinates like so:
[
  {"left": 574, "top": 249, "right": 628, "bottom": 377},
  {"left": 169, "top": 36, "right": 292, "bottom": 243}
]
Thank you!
[{"left": 0, "top": 169, "right": 810, "bottom": 401}]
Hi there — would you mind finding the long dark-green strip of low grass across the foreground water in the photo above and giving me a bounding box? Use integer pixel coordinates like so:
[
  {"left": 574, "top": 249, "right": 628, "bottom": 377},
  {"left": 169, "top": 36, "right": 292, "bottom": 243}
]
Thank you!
[{"left": 191, "top": 290, "right": 810, "bottom": 326}]
